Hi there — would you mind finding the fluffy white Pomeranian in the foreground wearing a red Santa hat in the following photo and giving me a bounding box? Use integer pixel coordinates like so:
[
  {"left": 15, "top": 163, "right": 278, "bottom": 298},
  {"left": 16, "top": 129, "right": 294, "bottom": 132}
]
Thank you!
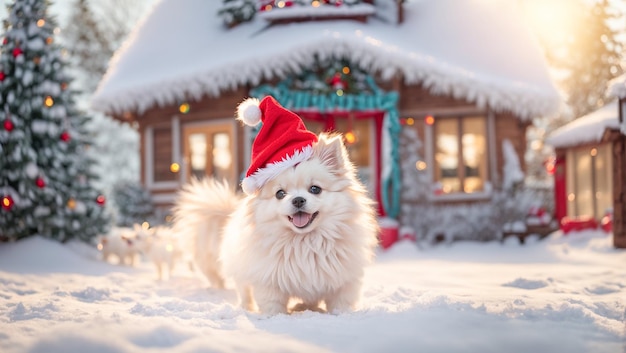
[{"left": 169, "top": 97, "right": 379, "bottom": 315}]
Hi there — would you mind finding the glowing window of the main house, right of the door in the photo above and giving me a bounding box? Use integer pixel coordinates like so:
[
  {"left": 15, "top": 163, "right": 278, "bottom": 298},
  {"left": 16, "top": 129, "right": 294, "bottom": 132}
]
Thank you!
[{"left": 433, "top": 116, "right": 488, "bottom": 194}]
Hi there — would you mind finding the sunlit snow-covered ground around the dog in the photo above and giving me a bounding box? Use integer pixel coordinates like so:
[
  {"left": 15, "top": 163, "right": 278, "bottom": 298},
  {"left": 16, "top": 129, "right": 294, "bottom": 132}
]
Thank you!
[{"left": 0, "top": 232, "right": 626, "bottom": 353}]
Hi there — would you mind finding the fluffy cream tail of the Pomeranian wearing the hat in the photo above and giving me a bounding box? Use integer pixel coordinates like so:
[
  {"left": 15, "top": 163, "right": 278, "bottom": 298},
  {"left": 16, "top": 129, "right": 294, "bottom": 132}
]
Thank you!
[{"left": 172, "top": 178, "right": 240, "bottom": 287}]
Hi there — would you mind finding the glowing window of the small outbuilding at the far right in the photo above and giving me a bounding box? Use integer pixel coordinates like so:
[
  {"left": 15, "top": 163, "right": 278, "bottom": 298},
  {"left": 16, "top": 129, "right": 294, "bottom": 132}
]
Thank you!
[{"left": 566, "top": 144, "right": 613, "bottom": 219}]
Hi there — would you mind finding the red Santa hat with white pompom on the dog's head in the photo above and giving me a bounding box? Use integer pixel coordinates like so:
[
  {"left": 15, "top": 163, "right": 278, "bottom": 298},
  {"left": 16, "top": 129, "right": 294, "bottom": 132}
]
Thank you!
[{"left": 237, "top": 96, "right": 317, "bottom": 195}]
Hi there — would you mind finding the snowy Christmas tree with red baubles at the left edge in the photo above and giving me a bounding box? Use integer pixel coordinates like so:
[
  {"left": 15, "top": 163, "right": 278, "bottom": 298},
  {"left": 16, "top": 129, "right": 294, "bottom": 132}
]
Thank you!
[{"left": 0, "top": 0, "right": 108, "bottom": 241}]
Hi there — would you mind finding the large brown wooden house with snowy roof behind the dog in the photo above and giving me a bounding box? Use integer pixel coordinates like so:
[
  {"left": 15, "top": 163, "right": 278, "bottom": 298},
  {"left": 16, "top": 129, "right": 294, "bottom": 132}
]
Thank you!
[{"left": 92, "top": 0, "right": 560, "bottom": 230}]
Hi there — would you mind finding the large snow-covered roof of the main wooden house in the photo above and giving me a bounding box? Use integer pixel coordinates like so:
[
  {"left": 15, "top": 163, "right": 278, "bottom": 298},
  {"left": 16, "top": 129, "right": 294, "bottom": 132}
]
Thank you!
[{"left": 91, "top": 0, "right": 561, "bottom": 118}]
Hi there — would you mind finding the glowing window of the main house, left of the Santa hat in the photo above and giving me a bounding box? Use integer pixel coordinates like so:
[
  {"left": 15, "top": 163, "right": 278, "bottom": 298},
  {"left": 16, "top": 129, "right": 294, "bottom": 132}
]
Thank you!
[{"left": 183, "top": 123, "right": 236, "bottom": 185}]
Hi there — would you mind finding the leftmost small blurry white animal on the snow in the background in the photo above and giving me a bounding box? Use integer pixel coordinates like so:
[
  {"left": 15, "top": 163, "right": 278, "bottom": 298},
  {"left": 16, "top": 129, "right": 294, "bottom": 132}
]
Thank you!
[{"left": 97, "top": 227, "right": 139, "bottom": 266}]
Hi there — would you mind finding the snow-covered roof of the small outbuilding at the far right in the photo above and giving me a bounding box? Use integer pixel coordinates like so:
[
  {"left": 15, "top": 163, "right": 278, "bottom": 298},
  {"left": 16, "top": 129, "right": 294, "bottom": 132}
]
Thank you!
[{"left": 546, "top": 101, "right": 619, "bottom": 148}]
